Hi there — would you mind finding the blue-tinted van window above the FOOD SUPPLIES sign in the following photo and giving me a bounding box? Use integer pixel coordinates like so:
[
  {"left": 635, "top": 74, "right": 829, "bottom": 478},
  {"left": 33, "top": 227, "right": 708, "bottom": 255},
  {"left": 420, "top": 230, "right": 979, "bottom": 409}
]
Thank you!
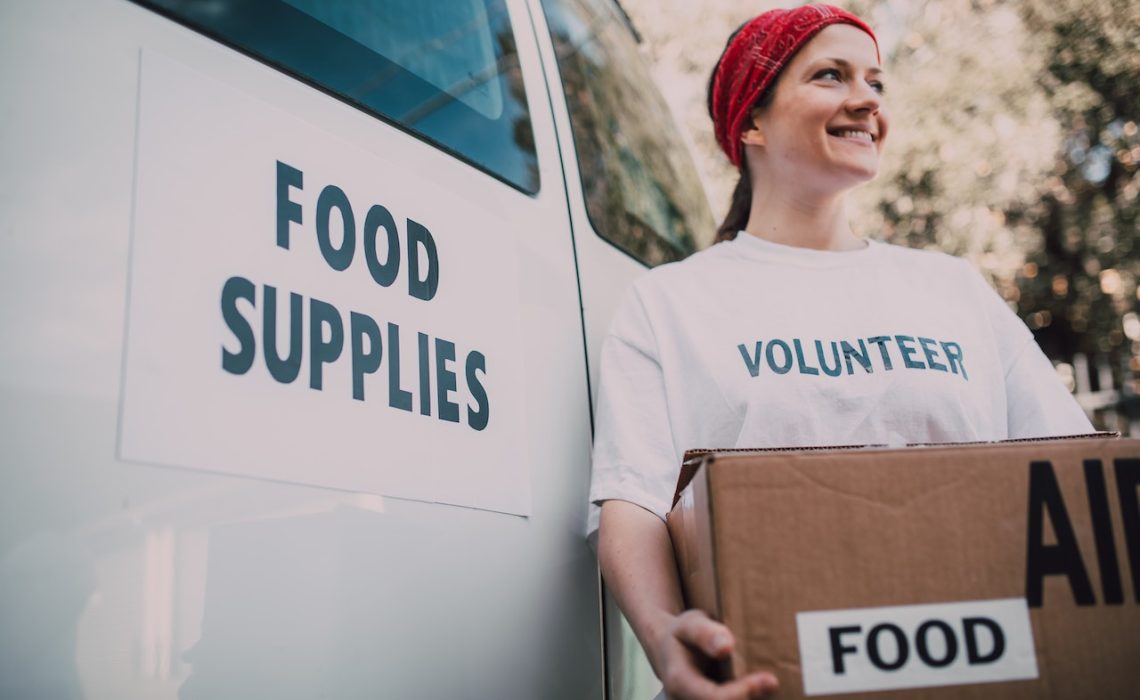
[{"left": 137, "top": 0, "right": 538, "bottom": 194}]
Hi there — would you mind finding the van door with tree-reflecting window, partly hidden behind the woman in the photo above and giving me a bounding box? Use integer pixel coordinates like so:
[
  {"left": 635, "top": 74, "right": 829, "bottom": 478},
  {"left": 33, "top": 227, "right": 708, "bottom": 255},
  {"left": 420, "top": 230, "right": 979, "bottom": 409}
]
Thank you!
[{"left": 528, "top": 0, "right": 715, "bottom": 700}]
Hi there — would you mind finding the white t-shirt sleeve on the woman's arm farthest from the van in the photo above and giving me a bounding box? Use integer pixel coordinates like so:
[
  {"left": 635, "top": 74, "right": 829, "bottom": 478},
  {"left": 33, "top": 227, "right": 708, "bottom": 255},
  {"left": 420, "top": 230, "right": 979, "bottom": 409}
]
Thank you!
[{"left": 971, "top": 263, "right": 1093, "bottom": 438}]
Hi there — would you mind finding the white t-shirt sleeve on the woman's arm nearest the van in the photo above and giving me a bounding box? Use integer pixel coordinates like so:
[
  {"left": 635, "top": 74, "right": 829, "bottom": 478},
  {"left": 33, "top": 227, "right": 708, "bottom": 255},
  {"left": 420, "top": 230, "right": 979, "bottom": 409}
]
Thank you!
[{"left": 589, "top": 286, "right": 679, "bottom": 524}]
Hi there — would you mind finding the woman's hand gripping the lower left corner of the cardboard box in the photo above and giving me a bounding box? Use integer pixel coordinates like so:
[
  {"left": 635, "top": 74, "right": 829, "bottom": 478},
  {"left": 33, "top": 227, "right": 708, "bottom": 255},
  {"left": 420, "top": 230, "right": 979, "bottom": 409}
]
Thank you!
[{"left": 654, "top": 610, "right": 777, "bottom": 700}]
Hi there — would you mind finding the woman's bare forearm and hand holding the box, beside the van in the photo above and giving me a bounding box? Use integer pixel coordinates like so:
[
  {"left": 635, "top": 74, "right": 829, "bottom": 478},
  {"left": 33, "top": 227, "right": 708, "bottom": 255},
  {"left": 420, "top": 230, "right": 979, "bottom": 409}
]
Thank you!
[{"left": 597, "top": 500, "right": 776, "bottom": 700}]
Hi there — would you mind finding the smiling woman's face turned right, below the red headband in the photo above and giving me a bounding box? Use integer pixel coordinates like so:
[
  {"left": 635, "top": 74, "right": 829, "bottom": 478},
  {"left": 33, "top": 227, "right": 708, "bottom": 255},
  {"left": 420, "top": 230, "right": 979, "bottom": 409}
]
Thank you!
[{"left": 743, "top": 24, "right": 888, "bottom": 190}]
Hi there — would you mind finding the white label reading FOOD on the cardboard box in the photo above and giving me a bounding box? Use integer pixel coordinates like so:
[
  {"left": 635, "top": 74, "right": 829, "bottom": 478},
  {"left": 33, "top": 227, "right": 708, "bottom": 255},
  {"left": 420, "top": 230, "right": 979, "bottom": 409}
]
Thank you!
[{"left": 796, "top": 599, "right": 1037, "bottom": 695}]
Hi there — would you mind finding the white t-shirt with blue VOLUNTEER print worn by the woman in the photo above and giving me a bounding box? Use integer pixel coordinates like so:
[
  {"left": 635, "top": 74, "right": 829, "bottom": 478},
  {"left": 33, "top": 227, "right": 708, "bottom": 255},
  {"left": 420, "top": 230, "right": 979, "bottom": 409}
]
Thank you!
[{"left": 589, "top": 233, "right": 1092, "bottom": 532}]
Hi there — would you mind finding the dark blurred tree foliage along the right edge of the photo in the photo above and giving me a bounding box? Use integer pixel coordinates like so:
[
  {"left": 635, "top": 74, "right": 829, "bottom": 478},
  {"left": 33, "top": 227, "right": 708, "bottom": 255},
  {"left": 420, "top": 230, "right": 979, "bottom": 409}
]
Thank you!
[{"left": 1018, "top": 0, "right": 1140, "bottom": 401}]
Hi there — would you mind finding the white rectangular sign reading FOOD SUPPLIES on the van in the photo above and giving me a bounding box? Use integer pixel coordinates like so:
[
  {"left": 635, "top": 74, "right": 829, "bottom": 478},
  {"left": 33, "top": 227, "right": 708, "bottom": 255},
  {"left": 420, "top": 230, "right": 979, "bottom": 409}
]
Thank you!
[{"left": 120, "top": 51, "right": 530, "bottom": 514}]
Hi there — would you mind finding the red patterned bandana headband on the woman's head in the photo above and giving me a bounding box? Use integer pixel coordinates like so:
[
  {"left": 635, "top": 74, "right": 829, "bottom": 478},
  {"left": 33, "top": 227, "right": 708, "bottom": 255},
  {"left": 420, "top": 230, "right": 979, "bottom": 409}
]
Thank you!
[{"left": 711, "top": 5, "right": 879, "bottom": 168}]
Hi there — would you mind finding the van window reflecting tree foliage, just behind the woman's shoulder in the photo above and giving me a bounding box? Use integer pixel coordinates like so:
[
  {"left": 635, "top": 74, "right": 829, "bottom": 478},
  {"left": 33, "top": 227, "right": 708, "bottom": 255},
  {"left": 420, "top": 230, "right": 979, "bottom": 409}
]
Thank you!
[{"left": 543, "top": 0, "right": 715, "bottom": 266}]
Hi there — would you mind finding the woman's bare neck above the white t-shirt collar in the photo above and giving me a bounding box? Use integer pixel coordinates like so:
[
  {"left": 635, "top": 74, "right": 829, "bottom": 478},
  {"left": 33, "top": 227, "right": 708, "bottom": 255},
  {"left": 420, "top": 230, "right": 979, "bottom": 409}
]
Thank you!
[{"left": 744, "top": 188, "right": 866, "bottom": 251}]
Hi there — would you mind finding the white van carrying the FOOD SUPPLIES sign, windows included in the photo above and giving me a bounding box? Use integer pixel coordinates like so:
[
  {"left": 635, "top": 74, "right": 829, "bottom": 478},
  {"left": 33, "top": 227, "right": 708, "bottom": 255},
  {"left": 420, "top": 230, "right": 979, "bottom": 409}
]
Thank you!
[{"left": 0, "top": 0, "right": 714, "bottom": 700}]
